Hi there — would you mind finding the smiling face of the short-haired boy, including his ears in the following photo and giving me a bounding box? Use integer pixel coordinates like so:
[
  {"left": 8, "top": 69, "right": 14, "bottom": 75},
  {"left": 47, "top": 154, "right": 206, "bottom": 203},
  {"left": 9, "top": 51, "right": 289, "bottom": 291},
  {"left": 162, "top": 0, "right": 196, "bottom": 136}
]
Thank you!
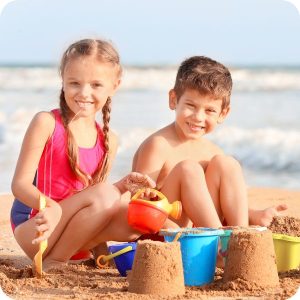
[{"left": 169, "top": 89, "right": 229, "bottom": 139}]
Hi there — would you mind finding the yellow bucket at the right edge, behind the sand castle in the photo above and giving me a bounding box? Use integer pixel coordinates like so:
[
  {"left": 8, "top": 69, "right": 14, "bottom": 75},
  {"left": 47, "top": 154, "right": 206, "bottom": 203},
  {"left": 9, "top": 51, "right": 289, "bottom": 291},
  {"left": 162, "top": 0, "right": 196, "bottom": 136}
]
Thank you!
[{"left": 273, "top": 233, "right": 300, "bottom": 272}]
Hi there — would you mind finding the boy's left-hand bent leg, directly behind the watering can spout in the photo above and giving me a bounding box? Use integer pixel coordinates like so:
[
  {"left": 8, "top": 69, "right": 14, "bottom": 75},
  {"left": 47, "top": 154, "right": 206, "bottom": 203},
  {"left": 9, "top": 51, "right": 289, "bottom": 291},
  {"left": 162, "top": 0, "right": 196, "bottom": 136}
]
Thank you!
[{"left": 161, "top": 160, "right": 222, "bottom": 228}]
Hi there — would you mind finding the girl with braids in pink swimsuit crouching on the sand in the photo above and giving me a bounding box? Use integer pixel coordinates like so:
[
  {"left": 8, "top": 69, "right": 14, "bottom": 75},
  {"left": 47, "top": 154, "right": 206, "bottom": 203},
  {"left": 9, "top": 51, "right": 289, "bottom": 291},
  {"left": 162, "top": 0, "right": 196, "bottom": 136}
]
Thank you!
[{"left": 11, "top": 39, "right": 154, "bottom": 270}]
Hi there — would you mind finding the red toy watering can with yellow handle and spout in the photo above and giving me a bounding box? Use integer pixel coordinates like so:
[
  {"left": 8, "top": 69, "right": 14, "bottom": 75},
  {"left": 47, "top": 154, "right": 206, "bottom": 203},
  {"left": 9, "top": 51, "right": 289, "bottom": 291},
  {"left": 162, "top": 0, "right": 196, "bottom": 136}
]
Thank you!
[{"left": 127, "top": 189, "right": 182, "bottom": 233}]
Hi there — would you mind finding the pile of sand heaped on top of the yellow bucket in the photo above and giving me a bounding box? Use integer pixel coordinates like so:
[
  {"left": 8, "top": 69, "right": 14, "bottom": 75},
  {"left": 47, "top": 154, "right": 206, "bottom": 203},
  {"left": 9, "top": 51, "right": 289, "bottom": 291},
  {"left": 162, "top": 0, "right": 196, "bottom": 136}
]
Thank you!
[{"left": 269, "top": 216, "right": 300, "bottom": 237}]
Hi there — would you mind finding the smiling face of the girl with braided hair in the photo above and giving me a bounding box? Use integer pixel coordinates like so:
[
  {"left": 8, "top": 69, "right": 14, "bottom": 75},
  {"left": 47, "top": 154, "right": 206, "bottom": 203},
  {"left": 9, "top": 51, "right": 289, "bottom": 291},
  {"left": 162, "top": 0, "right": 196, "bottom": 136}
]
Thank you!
[{"left": 62, "top": 56, "right": 119, "bottom": 117}]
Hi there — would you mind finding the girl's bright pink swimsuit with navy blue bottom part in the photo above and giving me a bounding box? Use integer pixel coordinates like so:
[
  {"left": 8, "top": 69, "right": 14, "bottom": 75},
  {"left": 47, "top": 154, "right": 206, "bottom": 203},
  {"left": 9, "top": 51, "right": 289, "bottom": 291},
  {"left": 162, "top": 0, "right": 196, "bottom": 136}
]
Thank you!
[{"left": 11, "top": 109, "right": 105, "bottom": 230}]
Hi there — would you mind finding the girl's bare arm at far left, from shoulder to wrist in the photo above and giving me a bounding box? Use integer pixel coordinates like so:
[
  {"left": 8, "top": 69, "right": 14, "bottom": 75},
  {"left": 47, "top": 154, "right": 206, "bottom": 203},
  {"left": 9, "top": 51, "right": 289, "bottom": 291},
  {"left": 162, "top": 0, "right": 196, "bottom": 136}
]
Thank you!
[{"left": 11, "top": 112, "right": 55, "bottom": 209}]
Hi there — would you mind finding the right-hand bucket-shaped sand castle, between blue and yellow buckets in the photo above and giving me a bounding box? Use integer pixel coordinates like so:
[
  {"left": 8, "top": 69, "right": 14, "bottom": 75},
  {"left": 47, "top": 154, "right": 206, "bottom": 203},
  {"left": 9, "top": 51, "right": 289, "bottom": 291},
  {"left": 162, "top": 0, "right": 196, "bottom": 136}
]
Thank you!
[{"left": 224, "top": 228, "right": 279, "bottom": 287}]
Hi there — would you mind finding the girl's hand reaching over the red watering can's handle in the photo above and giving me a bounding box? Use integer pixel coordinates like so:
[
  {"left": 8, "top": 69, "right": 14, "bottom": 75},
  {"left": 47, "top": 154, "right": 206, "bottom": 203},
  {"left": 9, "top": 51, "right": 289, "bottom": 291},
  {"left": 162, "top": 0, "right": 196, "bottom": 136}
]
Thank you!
[{"left": 116, "top": 172, "right": 155, "bottom": 196}]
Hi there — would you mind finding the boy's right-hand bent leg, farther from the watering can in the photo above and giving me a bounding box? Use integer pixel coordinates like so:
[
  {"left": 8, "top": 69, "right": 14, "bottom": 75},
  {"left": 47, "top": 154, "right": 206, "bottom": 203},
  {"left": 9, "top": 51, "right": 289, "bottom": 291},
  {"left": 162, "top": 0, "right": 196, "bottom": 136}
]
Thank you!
[{"left": 205, "top": 155, "right": 249, "bottom": 226}]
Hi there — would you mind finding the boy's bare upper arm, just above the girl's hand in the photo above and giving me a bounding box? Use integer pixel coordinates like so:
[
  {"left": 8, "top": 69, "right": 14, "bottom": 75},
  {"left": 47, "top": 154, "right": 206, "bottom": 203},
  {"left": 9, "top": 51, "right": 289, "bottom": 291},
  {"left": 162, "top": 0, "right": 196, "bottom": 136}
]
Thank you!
[{"left": 132, "top": 136, "right": 168, "bottom": 182}]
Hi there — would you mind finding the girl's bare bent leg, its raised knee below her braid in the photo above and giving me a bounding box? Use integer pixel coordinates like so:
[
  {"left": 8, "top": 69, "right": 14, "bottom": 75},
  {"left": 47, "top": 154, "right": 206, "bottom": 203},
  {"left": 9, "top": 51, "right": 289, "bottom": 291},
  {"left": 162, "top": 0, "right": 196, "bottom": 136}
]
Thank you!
[{"left": 15, "top": 183, "right": 120, "bottom": 261}]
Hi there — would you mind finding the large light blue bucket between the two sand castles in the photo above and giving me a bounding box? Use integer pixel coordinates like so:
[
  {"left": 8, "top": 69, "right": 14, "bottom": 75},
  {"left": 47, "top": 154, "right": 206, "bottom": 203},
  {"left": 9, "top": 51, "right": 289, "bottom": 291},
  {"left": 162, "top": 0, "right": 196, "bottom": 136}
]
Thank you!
[{"left": 161, "top": 228, "right": 224, "bottom": 286}]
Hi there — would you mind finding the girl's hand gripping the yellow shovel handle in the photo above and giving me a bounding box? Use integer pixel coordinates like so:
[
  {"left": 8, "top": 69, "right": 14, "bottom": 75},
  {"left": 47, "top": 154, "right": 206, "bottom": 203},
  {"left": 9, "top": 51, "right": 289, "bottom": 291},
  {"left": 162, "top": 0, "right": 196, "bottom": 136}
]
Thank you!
[{"left": 32, "top": 201, "right": 62, "bottom": 244}]
